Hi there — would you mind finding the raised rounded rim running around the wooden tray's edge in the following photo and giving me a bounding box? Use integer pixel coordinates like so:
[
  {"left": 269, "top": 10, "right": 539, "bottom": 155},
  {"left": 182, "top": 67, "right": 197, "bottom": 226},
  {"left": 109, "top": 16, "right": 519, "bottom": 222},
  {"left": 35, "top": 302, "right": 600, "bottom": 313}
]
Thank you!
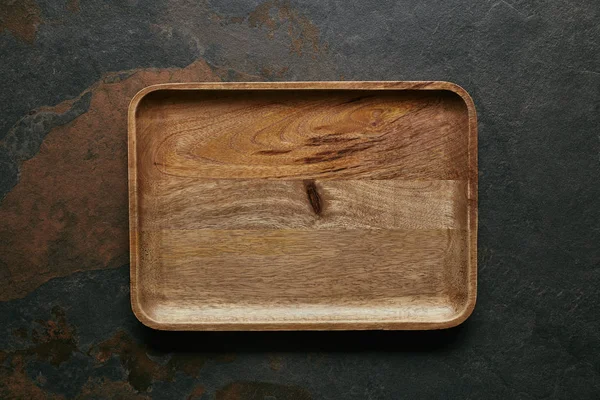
[{"left": 127, "top": 81, "right": 478, "bottom": 331}]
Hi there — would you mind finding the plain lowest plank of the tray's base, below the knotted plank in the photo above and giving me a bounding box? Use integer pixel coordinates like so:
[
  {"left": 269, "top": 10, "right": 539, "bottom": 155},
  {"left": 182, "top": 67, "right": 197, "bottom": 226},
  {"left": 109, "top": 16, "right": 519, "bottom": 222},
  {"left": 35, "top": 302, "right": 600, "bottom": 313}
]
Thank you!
[{"left": 142, "top": 230, "right": 465, "bottom": 306}]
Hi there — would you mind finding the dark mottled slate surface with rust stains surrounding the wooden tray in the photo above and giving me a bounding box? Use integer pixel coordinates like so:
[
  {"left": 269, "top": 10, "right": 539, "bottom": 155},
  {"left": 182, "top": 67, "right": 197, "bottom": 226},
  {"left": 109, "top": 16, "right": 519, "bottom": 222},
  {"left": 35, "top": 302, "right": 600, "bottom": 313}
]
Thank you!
[{"left": 0, "top": 0, "right": 600, "bottom": 400}]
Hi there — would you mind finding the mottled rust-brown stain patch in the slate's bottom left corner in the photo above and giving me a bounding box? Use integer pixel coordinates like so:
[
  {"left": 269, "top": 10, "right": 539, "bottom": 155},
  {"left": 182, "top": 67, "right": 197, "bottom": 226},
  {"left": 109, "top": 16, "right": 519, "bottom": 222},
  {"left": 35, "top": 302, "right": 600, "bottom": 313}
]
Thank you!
[{"left": 0, "top": 306, "right": 239, "bottom": 400}]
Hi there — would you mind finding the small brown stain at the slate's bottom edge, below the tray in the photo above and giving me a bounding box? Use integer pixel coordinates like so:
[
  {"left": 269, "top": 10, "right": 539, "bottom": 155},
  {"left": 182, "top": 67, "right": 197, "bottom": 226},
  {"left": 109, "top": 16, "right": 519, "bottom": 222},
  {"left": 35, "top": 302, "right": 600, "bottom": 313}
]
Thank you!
[{"left": 216, "top": 382, "right": 312, "bottom": 400}]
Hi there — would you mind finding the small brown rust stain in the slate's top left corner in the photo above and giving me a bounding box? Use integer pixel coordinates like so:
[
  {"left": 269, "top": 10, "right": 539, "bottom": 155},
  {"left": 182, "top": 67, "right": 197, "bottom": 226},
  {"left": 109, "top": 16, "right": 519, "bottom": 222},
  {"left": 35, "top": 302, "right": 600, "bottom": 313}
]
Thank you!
[{"left": 0, "top": 0, "right": 42, "bottom": 43}]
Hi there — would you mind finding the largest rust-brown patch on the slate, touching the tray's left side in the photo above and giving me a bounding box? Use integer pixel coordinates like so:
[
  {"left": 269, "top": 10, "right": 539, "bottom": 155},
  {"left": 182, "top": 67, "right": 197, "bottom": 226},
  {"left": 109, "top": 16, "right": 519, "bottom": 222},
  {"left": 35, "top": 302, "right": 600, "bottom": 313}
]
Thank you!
[{"left": 0, "top": 61, "right": 220, "bottom": 301}]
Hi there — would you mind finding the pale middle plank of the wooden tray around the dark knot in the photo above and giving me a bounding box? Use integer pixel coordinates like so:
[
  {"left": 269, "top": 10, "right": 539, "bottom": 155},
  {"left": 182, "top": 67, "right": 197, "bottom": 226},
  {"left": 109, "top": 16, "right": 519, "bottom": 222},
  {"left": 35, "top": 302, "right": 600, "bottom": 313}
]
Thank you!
[{"left": 141, "top": 178, "right": 466, "bottom": 229}]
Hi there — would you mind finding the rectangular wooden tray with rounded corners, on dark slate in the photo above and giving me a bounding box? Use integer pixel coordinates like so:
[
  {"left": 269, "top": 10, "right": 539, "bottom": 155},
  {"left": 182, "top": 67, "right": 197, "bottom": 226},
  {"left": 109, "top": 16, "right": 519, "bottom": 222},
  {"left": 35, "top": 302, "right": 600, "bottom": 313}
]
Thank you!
[{"left": 129, "top": 82, "right": 477, "bottom": 330}]
